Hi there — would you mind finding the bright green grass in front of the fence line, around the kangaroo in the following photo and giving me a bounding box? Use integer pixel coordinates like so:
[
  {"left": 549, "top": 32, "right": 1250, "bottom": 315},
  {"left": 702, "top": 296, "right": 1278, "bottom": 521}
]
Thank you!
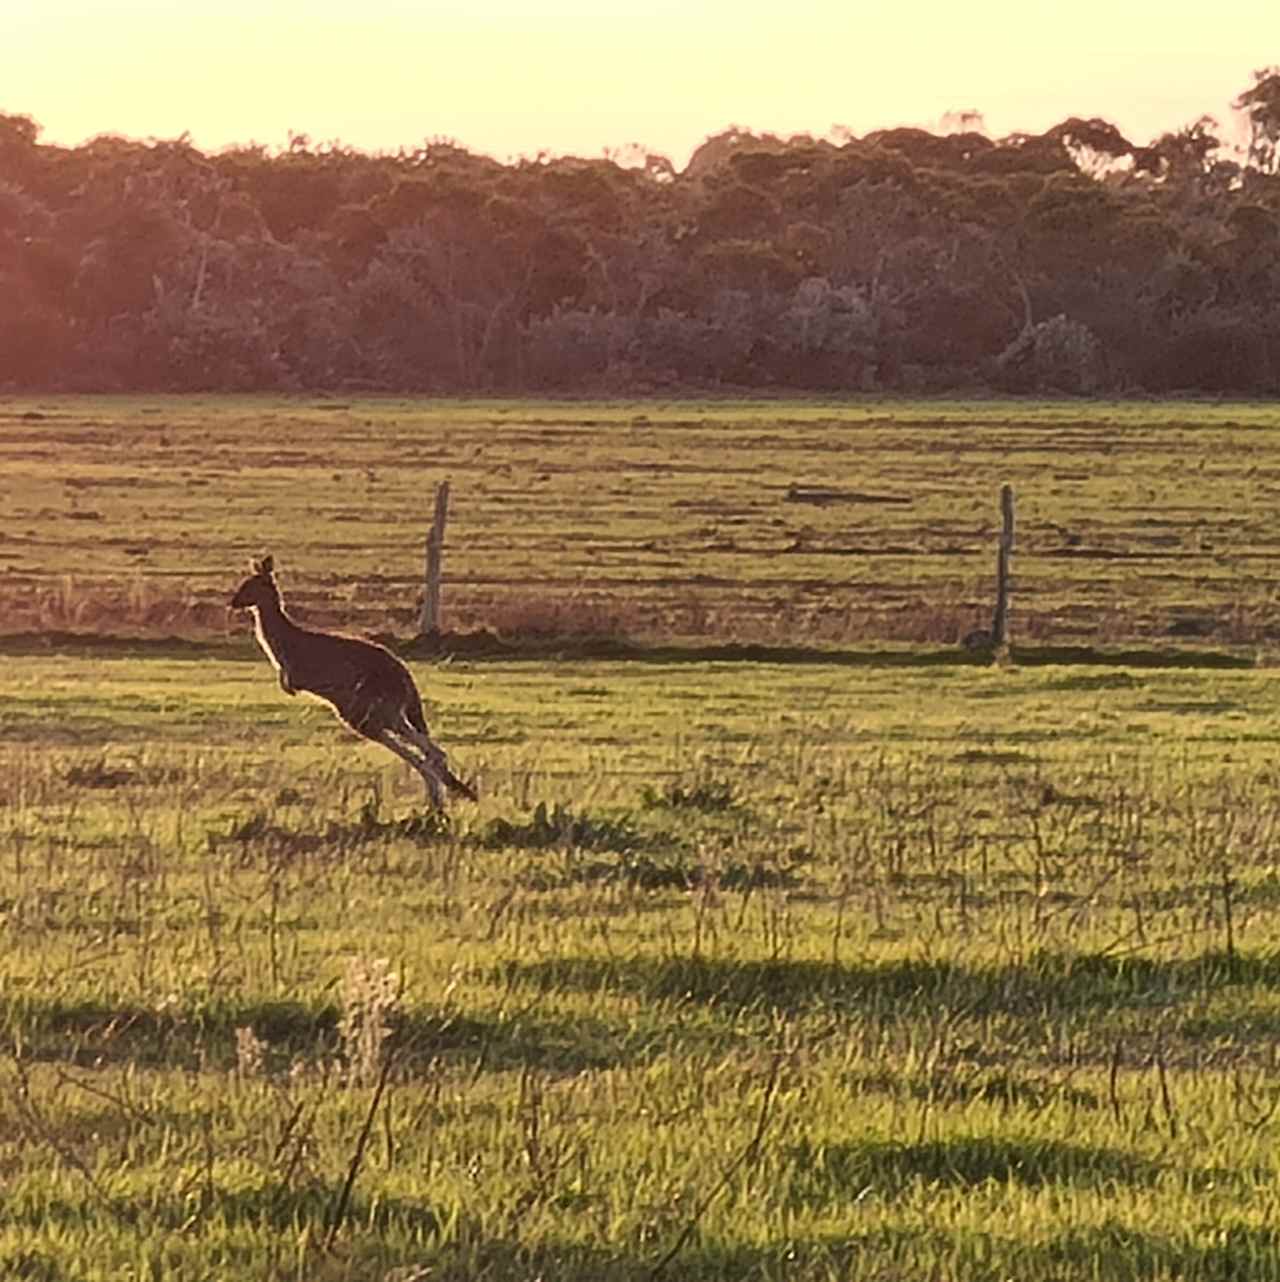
[{"left": 0, "top": 651, "right": 1280, "bottom": 1282}]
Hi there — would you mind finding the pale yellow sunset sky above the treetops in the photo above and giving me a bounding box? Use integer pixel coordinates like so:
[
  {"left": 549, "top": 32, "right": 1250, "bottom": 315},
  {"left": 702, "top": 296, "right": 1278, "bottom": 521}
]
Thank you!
[{"left": 0, "top": 0, "right": 1280, "bottom": 166}]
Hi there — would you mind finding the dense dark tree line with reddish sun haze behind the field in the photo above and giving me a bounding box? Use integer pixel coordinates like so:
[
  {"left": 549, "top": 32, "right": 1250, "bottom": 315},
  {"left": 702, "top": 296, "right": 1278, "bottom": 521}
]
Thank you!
[{"left": 0, "top": 68, "right": 1280, "bottom": 394}]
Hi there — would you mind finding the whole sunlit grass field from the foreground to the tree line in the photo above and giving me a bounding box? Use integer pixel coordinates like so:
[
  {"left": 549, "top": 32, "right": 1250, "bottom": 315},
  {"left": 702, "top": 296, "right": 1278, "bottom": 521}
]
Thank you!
[{"left": 0, "top": 401, "right": 1280, "bottom": 1282}]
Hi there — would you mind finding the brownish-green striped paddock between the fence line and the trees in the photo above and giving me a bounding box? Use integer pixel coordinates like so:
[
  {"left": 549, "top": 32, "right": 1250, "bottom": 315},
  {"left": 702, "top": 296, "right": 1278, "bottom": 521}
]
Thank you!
[{"left": 0, "top": 397, "right": 1280, "bottom": 646}]
